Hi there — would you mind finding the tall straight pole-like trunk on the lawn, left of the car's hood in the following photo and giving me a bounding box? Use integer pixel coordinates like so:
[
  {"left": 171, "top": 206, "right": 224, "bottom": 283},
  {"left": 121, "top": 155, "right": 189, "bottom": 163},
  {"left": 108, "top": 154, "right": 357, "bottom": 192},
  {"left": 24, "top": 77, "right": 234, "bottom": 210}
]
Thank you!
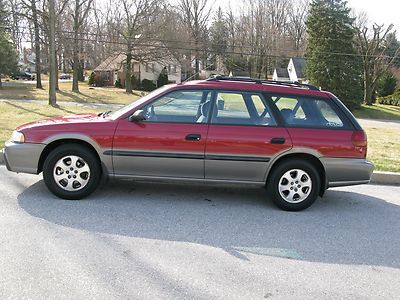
[{"left": 49, "top": 0, "right": 57, "bottom": 106}]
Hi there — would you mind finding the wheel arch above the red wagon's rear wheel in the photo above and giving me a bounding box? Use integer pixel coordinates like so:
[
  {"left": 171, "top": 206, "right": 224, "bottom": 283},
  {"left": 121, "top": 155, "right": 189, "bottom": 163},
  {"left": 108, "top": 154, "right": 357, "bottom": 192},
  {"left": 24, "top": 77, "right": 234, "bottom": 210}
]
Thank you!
[{"left": 265, "top": 151, "right": 328, "bottom": 197}]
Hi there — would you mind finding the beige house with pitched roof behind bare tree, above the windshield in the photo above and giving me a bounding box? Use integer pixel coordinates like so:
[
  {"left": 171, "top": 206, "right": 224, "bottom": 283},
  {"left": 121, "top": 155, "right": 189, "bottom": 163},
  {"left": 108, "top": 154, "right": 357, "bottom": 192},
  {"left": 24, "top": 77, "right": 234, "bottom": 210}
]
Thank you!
[{"left": 94, "top": 54, "right": 181, "bottom": 86}]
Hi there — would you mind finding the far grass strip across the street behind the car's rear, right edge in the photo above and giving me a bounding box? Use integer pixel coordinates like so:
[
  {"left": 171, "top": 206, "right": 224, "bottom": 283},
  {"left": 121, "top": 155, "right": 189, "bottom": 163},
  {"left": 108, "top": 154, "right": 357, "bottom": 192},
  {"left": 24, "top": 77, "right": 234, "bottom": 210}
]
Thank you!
[{"left": 353, "top": 104, "right": 400, "bottom": 120}]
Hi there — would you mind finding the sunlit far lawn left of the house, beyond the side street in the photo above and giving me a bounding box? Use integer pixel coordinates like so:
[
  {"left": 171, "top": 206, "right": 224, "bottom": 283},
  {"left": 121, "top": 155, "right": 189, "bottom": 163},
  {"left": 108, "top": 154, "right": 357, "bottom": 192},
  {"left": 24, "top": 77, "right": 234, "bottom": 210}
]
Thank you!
[{"left": 0, "top": 81, "right": 142, "bottom": 104}]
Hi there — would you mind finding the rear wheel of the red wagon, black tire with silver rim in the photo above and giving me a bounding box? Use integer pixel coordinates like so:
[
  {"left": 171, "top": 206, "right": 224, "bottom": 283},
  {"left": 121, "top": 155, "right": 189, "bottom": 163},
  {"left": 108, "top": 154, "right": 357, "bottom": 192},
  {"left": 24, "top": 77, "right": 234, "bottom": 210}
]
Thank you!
[{"left": 267, "top": 159, "right": 321, "bottom": 211}]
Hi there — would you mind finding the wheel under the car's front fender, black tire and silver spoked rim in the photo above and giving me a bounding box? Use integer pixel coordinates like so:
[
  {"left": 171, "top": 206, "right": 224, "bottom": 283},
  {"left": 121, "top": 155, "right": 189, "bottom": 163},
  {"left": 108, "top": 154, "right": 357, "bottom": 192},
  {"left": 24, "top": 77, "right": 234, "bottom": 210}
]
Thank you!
[{"left": 43, "top": 144, "right": 101, "bottom": 200}]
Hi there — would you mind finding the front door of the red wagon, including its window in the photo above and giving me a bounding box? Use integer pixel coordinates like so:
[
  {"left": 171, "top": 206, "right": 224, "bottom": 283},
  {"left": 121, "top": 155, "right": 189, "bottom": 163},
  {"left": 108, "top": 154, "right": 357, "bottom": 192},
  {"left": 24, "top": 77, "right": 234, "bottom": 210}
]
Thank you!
[{"left": 112, "top": 90, "right": 212, "bottom": 179}]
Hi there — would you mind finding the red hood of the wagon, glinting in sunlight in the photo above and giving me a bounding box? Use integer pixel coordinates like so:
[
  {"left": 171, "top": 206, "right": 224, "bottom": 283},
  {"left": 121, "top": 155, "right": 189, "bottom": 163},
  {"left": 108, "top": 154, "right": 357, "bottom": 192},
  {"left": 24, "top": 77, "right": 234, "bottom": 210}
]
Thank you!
[{"left": 16, "top": 114, "right": 104, "bottom": 131}]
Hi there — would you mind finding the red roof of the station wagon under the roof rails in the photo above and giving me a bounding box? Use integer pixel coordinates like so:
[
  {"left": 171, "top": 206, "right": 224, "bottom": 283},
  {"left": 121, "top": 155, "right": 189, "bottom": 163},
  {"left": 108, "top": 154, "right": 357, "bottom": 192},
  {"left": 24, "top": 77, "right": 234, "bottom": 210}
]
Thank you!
[{"left": 176, "top": 79, "right": 329, "bottom": 98}]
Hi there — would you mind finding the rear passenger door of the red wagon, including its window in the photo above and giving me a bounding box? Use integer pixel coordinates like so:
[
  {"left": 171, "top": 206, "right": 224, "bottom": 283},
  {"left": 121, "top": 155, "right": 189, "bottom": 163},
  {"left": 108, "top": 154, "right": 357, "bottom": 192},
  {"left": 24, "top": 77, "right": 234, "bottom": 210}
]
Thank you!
[{"left": 205, "top": 91, "right": 292, "bottom": 182}]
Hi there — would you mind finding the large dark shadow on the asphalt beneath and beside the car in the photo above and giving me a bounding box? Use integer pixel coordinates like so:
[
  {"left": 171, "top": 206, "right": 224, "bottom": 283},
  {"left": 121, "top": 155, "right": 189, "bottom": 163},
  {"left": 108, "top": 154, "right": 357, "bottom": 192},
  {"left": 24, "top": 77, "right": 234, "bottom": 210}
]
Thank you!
[{"left": 18, "top": 181, "right": 400, "bottom": 268}]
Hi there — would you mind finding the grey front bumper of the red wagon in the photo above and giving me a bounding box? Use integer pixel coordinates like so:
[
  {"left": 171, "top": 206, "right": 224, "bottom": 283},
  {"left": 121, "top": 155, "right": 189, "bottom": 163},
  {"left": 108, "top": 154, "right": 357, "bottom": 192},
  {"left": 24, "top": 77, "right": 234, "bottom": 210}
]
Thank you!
[{"left": 0, "top": 141, "right": 46, "bottom": 174}]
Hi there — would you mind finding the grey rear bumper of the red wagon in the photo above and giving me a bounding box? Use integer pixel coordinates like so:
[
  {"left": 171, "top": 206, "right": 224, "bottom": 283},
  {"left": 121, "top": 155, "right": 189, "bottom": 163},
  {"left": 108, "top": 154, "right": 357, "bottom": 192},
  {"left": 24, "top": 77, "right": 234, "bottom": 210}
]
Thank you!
[{"left": 321, "top": 158, "right": 374, "bottom": 188}]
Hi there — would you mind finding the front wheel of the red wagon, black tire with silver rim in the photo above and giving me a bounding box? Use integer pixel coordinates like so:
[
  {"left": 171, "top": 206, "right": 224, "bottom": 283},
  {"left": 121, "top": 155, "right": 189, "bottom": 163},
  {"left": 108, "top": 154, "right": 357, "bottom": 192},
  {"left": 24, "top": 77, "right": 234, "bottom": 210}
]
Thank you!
[{"left": 43, "top": 144, "right": 101, "bottom": 200}]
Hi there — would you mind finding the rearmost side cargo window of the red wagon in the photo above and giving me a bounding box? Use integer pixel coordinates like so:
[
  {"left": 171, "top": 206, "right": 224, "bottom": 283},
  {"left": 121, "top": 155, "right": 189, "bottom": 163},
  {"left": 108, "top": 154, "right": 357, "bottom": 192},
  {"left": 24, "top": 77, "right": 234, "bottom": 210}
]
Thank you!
[{"left": 272, "top": 96, "right": 345, "bottom": 128}]
